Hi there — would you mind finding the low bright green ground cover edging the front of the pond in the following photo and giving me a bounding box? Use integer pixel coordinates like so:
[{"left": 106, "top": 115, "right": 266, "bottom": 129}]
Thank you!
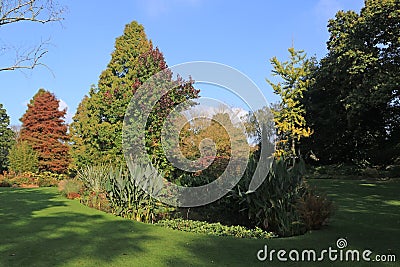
[{"left": 156, "top": 219, "right": 274, "bottom": 239}]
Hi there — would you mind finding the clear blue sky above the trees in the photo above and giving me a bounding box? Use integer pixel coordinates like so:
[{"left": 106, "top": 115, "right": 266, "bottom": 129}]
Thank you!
[{"left": 0, "top": 0, "right": 364, "bottom": 125}]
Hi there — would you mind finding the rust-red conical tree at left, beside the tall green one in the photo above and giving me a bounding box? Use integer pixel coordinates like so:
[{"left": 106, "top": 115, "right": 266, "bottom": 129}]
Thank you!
[{"left": 20, "top": 89, "right": 69, "bottom": 173}]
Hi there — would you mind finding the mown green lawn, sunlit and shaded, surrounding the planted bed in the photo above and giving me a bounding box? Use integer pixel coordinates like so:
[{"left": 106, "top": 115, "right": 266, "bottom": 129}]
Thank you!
[{"left": 0, "top": 180, "right": 400, "bottom": 266}]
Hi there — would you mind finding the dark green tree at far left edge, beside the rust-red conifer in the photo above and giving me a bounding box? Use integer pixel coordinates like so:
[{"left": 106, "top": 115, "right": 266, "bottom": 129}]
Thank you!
[{"left": 0, "top": 104, "right": 14, "bottom": 172}]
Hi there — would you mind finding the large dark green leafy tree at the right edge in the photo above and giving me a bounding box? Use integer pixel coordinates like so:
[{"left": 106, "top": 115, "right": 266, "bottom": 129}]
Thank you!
[{"left": 304, "top": 0, "right": 400, "bottom": 164}]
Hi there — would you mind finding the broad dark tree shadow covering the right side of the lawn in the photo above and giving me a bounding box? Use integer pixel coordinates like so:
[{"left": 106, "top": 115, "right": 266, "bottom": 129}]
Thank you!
[{"left": 163, "top": 180, "right": 400, "bottom": 266}]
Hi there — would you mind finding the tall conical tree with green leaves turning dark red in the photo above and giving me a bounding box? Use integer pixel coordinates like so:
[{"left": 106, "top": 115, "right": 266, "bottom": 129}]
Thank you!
[{"left": 70, "top": 21, "right": 198, "bottom": 174}]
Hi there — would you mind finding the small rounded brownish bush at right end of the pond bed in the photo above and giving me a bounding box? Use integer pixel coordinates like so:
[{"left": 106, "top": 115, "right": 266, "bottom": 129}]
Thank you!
[{"left": 297, "top": 188, "right": 334, "bottom": 230}]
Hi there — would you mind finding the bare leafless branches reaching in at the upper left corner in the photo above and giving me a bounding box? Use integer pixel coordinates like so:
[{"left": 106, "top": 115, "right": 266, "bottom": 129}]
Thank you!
[{"left": 0, "top": 0, "right": 65, "bottom": 71}]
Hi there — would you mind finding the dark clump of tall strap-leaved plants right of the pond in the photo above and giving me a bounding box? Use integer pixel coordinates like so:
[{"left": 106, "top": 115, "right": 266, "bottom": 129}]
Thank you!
[{"left": 235, "top": 158, "right": 306, "bottom": 236}]
